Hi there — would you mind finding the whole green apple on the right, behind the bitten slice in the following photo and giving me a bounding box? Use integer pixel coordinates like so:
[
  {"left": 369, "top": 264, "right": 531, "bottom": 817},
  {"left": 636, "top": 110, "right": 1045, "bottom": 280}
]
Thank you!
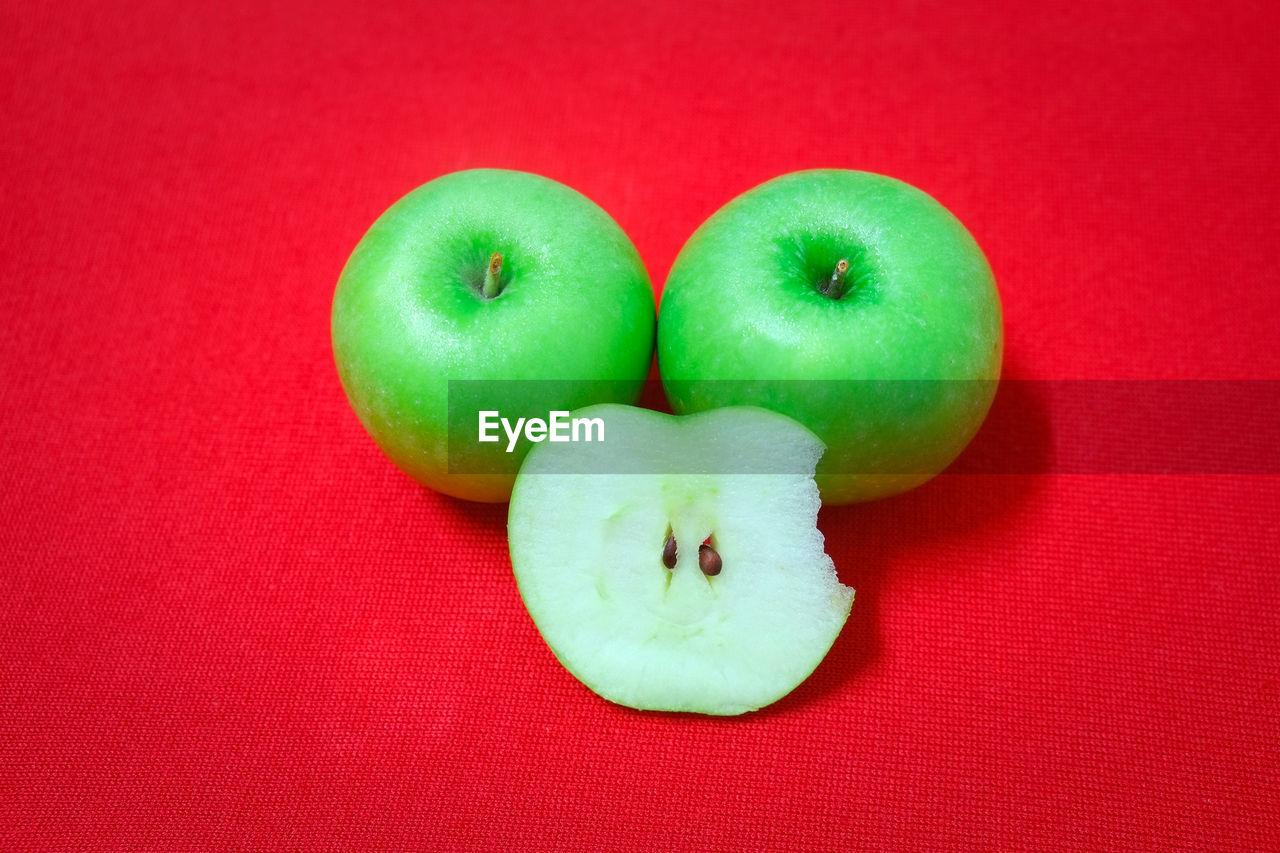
[{"left": 658, "top": 169, "right": 1004, "bottom": 505}]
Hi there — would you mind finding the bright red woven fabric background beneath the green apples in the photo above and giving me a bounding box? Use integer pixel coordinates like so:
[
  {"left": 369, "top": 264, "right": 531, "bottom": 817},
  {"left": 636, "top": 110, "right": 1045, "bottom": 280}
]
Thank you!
[{"left": 0, "top": 0, "right": 1280, "bottom": 850}]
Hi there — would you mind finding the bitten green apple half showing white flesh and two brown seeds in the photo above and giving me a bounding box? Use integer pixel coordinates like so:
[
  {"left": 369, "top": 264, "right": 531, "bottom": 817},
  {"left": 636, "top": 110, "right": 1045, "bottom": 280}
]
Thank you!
[{"left": 508, "top": 405, "right": 854, "bottom": 715}]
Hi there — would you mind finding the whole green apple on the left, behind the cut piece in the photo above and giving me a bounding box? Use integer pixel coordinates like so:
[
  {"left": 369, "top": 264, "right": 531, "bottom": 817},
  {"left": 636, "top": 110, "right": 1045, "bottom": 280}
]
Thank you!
[{"left": 332, "top": 169, "right": 655, "bottom": 502}]
